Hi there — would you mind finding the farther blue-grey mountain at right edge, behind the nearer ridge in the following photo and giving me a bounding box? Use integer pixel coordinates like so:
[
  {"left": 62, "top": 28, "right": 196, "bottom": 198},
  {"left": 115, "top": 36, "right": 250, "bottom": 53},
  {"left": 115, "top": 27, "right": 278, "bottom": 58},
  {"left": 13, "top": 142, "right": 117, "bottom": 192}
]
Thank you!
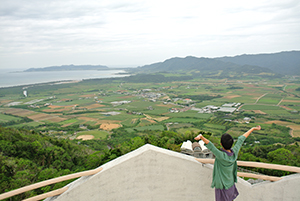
[{"left": 215, "top": 51, "right": 300, "bottom": 75}]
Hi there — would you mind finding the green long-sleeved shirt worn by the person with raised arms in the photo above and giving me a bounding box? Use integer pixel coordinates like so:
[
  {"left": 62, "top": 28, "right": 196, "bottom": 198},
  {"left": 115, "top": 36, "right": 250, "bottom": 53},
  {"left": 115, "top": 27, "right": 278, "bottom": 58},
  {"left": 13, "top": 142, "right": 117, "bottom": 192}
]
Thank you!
[{"left": 205, "top": 135, "right": 246, "bottom": 189}]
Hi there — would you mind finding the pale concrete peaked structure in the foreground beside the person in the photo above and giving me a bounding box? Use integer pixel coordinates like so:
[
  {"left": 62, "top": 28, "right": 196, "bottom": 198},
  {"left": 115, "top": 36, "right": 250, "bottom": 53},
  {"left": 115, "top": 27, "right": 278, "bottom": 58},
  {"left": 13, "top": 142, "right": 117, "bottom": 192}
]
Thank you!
[{"left": 46, "top": 144, "right": 300, "bottom": 201}]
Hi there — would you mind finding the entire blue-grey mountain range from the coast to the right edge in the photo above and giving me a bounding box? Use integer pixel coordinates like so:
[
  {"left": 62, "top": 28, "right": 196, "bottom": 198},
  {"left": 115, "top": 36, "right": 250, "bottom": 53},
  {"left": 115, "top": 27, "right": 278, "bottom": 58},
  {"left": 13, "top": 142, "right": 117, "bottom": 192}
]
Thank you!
[{"left": 132, "top": 51, "right": 300, "bottom": 75}]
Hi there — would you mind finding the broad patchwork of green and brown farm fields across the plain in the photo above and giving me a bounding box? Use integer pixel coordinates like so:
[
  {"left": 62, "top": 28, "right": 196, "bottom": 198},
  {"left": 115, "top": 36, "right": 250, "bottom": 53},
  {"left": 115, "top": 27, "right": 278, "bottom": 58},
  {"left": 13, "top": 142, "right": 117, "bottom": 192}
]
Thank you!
[{"left": 0, "top": 72, "right": 300, "bottom": 144}]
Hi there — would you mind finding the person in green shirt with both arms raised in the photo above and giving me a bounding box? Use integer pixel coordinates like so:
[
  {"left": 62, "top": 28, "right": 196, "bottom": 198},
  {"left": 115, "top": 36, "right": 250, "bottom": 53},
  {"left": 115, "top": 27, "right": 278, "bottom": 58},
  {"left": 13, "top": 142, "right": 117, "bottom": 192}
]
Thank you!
[{"left": 195, "top": 126, "right": 261, "bottom": 201}]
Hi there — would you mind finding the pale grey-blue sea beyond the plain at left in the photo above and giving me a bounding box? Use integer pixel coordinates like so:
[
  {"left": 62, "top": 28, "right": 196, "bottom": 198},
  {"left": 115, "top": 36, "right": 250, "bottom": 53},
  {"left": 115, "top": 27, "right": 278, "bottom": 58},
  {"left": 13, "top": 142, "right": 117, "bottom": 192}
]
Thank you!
[{"left": 0, "top": 69, "right": 128, "bottom": 88}]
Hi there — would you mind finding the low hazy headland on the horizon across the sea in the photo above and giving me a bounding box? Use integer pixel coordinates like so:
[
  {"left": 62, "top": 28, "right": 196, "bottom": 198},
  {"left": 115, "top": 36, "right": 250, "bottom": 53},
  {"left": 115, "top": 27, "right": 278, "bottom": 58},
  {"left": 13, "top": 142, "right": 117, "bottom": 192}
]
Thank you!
[{"left": 24, "top": 65, "right": 109, "bottom": 72}]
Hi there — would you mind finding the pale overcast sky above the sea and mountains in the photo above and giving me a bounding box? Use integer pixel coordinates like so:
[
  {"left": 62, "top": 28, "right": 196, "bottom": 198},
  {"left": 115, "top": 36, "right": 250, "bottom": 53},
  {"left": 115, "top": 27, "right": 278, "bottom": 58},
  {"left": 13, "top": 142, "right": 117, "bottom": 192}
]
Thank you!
[{"left": 0, "top": 0, "right": 300, "bottom": 68}]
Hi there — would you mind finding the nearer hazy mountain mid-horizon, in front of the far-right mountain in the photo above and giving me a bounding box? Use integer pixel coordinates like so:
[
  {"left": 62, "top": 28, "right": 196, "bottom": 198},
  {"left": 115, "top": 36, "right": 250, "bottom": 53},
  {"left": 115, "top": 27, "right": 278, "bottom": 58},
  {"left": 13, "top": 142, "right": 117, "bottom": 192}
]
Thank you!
[{"left": 132, "top": 56, "right": 275, "bottom": 77}]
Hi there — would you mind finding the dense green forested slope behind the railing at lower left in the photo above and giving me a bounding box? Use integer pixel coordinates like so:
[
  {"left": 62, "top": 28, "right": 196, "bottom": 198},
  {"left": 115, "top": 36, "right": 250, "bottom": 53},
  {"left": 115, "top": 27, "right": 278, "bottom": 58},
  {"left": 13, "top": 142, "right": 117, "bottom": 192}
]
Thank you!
[{"left": 0, "top": 126, "right": 101, "bottom": 200}]
